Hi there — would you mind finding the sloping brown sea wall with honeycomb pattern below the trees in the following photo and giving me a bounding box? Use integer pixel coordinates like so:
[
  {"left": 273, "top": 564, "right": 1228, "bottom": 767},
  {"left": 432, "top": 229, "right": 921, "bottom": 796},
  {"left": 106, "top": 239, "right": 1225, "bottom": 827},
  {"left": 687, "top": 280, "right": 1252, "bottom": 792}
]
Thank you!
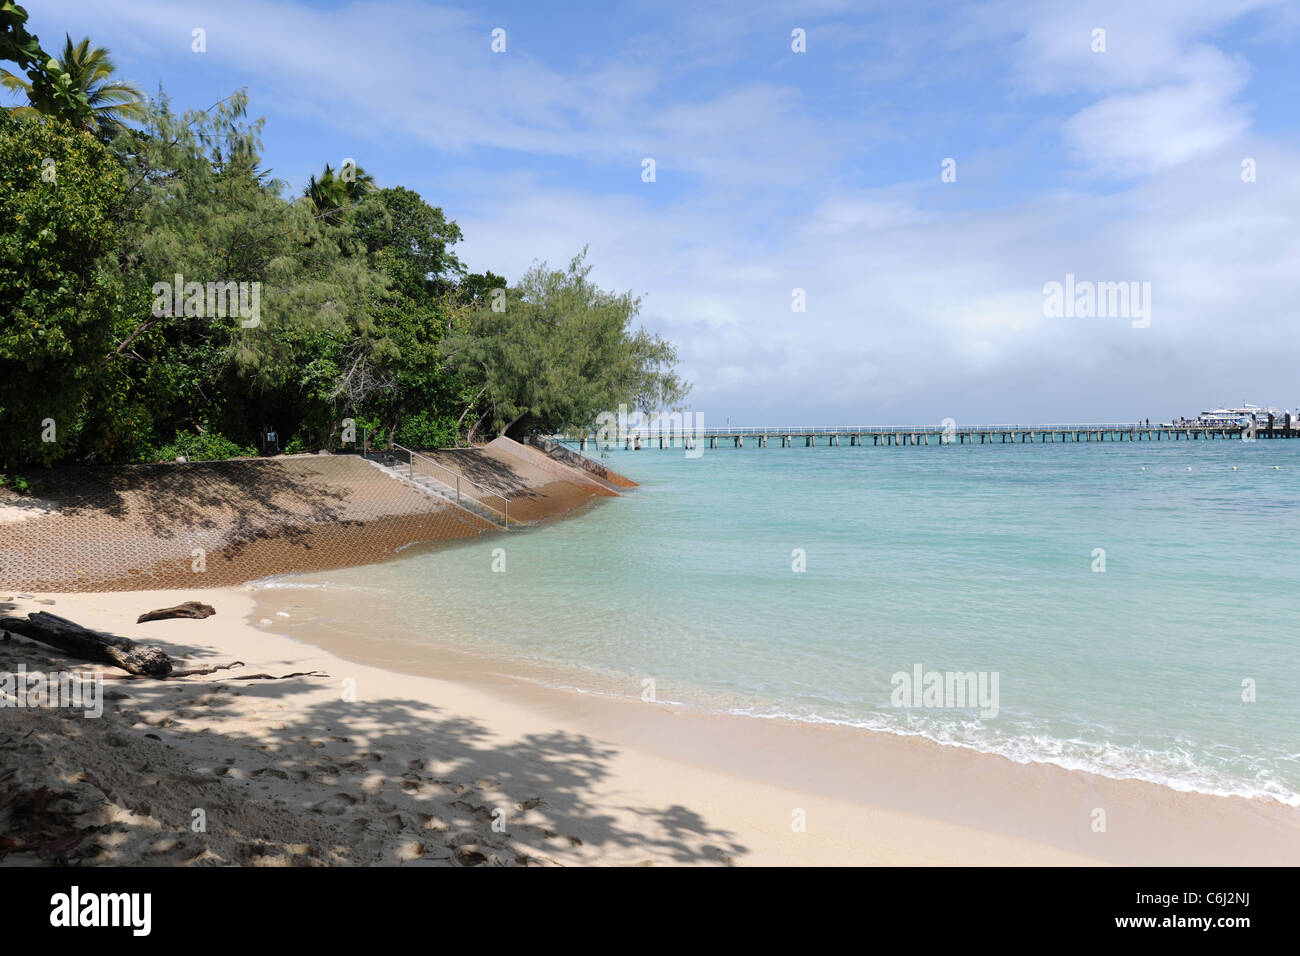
[{"left": 0, "top": 447, "right": 611, "bottom": 592}]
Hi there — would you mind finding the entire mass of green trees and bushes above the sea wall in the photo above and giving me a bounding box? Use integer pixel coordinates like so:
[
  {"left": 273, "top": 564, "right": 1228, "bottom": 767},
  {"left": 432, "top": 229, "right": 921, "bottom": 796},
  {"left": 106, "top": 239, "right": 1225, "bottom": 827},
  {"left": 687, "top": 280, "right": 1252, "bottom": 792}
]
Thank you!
[{"left": 0, "top": 25, "right": 685, "bottom": 467}]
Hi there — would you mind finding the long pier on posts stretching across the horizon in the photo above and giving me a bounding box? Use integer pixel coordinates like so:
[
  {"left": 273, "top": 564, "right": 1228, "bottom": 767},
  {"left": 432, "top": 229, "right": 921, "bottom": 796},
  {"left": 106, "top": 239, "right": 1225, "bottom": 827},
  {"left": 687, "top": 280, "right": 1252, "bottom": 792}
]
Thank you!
[{"left": 551, "top": 421, "right": 1300, "bottom": 451}]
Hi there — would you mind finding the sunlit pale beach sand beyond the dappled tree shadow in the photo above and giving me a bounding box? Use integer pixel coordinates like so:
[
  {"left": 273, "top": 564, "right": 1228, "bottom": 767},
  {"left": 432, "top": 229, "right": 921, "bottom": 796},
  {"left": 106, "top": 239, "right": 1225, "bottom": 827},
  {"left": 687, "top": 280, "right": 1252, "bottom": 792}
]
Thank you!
[{"left": 0, "top": 584, "right": 1300, "bottom": 865}]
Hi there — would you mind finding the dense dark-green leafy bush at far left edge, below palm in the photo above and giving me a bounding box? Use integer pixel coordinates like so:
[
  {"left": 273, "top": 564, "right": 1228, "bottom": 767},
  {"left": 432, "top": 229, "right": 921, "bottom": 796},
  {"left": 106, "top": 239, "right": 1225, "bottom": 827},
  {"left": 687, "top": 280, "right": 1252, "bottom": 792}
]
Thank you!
[{"left": 0, "top": 112, "right": 124, "bottom": 464}]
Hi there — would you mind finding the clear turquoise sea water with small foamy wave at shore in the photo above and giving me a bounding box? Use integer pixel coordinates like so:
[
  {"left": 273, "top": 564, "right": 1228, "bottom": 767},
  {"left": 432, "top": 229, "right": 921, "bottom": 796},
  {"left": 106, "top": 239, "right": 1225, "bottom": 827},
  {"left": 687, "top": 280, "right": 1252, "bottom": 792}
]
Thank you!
[{"left": 269, "top": 441, "right": 1300, "bottom": 805}]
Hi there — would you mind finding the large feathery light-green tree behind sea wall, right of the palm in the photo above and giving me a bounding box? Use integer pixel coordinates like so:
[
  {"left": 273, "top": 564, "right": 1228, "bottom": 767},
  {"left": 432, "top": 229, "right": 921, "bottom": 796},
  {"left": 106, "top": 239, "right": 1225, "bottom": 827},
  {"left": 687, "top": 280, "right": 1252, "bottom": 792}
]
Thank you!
[{"left": 101, "top": 92, "right": 386, "bottom": 454}]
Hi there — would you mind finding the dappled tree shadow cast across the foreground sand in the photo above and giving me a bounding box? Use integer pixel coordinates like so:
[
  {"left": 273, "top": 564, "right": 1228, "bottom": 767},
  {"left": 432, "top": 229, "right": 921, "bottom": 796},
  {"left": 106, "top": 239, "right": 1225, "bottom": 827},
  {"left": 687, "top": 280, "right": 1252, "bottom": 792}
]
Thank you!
[{"left": 0, "top": 647, "right": 746, "bottom": 865}]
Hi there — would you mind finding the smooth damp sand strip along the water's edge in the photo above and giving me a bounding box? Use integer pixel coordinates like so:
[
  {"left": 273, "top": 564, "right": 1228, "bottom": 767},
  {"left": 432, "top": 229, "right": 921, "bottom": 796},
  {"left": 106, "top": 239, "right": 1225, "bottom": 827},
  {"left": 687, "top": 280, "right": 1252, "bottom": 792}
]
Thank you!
[{"left": 251, "top": 574, "right": 1300, "bottom": 865}]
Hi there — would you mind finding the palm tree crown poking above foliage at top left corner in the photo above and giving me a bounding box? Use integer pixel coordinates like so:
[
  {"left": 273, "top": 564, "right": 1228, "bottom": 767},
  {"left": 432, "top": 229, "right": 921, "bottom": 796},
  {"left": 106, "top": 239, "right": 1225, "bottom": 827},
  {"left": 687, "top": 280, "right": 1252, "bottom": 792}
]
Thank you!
[{"left": 0, "top": 35, "right": 147, "bottom": 140}]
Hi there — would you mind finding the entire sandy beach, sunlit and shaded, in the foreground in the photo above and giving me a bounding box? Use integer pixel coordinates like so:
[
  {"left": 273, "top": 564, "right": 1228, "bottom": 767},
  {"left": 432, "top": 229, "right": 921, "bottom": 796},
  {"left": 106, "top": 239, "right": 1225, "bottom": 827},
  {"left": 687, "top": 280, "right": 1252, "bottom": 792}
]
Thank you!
[{"left": 0, "top": 585, "right": 1300, "bottom": 865}]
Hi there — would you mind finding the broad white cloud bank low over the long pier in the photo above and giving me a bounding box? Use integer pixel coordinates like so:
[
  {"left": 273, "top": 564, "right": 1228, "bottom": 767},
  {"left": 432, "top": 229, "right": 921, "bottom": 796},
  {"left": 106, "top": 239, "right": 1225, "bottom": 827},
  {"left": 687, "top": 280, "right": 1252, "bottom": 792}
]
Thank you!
[{"left": 463, "top": 132, "right": 1300, "bottom": 424}]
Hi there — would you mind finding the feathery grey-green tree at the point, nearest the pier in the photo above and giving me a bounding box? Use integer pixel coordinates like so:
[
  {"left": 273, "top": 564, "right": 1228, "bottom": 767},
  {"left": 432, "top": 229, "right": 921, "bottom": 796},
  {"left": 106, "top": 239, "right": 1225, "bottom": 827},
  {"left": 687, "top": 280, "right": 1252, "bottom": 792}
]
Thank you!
[{"left": 443, "top": 250, "right": 689, "bottom": 441}]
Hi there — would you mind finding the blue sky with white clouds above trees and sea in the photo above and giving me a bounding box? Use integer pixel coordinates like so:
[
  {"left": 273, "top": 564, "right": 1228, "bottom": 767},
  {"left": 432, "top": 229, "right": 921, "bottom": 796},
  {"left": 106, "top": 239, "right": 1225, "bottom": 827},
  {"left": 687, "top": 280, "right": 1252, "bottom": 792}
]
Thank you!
[{"left": 15, "top": 0, "right": 1300, "bottom": 427}]
